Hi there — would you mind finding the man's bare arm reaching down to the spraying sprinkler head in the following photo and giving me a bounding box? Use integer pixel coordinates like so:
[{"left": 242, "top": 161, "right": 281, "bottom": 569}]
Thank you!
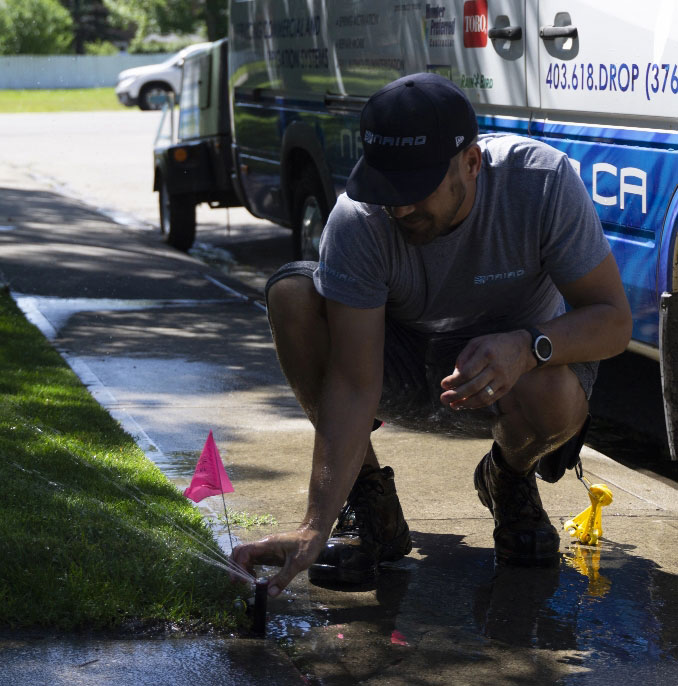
[{"left": 233, "top": 301, "right": 384, "bottom": 595}]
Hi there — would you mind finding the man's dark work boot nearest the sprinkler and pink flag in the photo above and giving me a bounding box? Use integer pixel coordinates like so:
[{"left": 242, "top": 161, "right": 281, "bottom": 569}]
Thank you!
[{"left": 308, "top": 465, "right": 412, "bottom": 584}]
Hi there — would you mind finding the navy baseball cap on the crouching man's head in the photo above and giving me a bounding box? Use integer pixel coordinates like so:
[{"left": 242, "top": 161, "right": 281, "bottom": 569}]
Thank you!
[{"left": 346, "top": 73, "right": 478, "bottom": 206}]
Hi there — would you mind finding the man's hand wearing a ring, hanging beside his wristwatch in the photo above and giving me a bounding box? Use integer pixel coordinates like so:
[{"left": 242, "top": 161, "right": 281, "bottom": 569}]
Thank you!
[{"left": 440, "top": 330, "right": 536, "bottom": 410}]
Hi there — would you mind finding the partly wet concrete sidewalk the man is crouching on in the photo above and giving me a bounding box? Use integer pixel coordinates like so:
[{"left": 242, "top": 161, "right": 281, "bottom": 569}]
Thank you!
[{"left": 0, "top": 168, "right": 678, "bottom": 685}]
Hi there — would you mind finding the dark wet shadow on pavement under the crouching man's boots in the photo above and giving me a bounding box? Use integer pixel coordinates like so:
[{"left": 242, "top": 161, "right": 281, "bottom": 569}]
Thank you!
[{"left": 270, "top": 531, "right": 678, "bottom": 686}]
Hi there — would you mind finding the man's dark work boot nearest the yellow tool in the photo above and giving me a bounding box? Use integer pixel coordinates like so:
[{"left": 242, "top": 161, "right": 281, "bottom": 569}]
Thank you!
[{"left": 473, "top": 443, "right": 560, "bottom": 566}]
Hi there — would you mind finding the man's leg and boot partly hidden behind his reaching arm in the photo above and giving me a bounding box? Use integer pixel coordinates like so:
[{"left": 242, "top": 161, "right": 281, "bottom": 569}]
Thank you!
[{"left": 267, "top": 265, "right": 412, "bottom": 583}]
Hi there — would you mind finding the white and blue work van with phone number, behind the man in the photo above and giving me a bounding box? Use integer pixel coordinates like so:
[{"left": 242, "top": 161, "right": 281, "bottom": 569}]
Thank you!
[{"left": 229, "top": 0, "right": 678, "bottom": 459}]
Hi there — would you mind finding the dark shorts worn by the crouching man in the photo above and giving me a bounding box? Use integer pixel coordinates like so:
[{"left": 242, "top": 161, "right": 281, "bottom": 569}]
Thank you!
[{"left": 266, "top": 262, "right": 598, "bottom": 438}]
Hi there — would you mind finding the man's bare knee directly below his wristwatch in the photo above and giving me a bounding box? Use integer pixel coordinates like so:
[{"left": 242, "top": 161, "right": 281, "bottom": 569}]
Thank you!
[{"left": 499, "top": 365, "right": 588, "bottom": 446}]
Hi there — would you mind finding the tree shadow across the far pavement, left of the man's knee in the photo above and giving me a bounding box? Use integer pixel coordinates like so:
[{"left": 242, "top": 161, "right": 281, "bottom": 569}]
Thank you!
[{"left": 0, "top": 188, "right": 231, "bottom": 298}]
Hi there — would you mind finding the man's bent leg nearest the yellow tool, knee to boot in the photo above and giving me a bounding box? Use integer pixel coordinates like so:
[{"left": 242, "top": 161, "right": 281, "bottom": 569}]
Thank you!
[{"left": 474, "top": 366, "right": 588, "bottom": 565}]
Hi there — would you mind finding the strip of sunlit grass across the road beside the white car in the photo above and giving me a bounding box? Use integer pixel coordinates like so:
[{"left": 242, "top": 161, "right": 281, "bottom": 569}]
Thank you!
[{"left": 0, "top": 88, "right": 127, "bottom": 113}]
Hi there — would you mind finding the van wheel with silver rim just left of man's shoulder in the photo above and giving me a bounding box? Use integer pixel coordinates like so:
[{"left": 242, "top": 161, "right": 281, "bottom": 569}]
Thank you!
[{"left": 293, "top": 168, "right": 328, "bottom": 260}]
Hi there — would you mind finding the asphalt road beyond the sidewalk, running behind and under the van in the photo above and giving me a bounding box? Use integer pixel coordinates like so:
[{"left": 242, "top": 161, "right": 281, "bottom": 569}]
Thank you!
[{"left": 0, "top": 109, "right": 678, "bottom": 478}]
